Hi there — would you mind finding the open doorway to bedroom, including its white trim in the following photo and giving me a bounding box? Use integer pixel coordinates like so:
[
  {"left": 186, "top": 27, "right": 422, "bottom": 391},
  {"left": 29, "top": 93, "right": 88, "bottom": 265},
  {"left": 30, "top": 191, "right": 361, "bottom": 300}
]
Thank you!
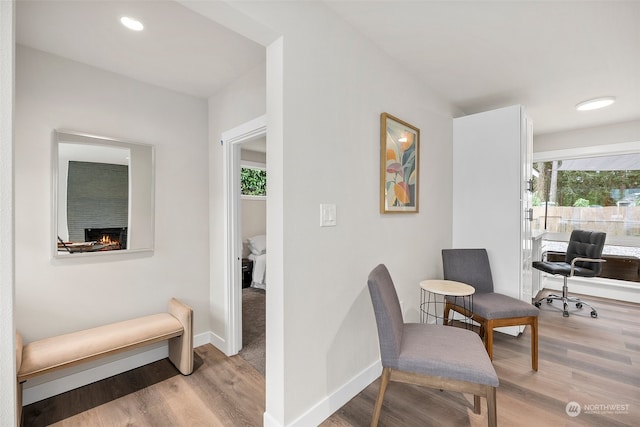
[{"left": 222, "top": 116, "right": 266, "bottom": 374}]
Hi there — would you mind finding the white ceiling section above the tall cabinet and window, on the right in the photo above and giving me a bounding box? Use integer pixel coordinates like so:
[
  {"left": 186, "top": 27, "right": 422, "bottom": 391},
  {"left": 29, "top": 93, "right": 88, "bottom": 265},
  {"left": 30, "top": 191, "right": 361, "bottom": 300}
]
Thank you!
[{"left": 327, "top": 0, "right": 640, "bottom": 134}]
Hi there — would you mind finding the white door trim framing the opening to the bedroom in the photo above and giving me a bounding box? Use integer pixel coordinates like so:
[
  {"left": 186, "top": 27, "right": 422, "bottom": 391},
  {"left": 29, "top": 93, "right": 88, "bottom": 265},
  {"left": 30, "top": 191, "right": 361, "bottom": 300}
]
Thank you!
[{"left": 221, "top": 115, "right": 267, "bottom": 356}]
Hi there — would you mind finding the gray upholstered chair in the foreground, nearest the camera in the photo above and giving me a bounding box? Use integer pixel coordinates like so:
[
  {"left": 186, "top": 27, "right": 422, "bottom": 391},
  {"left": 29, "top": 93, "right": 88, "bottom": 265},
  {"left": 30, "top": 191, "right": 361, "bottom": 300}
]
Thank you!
[{"left": 368, "top": 264, "right": 498, "bottom": 427}]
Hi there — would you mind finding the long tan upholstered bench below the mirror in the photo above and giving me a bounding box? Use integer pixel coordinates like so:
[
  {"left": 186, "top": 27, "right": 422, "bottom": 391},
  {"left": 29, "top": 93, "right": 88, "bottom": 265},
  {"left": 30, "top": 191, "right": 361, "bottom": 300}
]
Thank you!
[{"left": 16, "top": 298, "right": 193, "bottom": 426}]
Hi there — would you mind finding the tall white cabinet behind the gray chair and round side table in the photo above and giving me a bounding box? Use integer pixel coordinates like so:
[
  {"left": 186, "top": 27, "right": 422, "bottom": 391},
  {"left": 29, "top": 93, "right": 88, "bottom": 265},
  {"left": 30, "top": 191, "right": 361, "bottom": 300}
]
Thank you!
[{"left": 452, "top": 105, "right": 533, "bottom": 333}]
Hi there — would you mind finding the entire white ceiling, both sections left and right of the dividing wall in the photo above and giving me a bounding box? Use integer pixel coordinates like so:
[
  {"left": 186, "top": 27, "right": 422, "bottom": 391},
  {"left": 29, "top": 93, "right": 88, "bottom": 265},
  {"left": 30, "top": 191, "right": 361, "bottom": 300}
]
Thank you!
[{"left": 16, "top": 0, "right": 640, "bottom": 134}]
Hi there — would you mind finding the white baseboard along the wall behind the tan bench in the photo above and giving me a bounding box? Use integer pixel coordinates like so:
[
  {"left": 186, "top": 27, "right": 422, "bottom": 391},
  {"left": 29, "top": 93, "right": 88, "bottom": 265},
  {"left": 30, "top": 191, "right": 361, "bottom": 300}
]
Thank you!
[{"left": 22, "top": 332, "right": 215, "bottom": 405}]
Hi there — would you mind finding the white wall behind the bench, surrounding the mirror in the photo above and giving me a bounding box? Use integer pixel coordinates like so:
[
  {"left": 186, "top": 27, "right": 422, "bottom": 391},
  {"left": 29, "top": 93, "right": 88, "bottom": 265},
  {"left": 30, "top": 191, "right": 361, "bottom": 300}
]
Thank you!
[{"left": 14, "top": 46, "right": 209, "bottom": 384}]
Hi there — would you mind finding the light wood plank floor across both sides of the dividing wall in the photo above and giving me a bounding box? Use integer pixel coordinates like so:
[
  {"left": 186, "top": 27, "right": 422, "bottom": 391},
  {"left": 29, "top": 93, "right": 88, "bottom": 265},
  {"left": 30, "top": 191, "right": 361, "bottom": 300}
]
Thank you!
[{"left": 23, "top": 297, "right": 640, "bottom": 427}]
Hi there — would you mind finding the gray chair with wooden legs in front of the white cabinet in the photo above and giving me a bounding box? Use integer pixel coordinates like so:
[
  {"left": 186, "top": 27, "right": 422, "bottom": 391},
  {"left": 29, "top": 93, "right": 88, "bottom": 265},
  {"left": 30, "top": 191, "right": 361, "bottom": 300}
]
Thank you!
[{"left": 442, "top": 249, "right": 540, "bottom": 371}]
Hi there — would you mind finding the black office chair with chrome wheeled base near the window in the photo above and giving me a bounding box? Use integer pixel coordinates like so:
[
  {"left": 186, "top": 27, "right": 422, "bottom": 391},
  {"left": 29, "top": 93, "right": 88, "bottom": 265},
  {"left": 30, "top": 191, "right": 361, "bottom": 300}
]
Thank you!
[{"left": 532, "top": 230, "right": 607, "bottom": 317}]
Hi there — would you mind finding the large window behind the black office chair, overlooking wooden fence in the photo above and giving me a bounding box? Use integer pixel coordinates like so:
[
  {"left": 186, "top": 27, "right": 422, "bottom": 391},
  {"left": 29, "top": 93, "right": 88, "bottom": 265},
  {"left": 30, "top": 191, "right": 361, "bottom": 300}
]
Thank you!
[{"left": 532, "top": 143, "right": 640, "bottom": 281}]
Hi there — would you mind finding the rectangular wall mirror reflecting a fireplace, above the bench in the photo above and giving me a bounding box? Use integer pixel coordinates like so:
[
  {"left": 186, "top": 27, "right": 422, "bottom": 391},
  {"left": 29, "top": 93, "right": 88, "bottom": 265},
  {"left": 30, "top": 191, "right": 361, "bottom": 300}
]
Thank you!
[{"left": 52, "top": 131, "right": 154, "bottom": 258}]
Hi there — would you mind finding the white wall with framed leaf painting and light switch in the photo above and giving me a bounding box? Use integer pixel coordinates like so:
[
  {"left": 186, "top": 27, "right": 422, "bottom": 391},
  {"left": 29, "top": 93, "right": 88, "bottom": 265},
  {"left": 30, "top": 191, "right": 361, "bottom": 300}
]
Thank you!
[{"left": 205, "top": 2, "right": 452, "bottom": 425}]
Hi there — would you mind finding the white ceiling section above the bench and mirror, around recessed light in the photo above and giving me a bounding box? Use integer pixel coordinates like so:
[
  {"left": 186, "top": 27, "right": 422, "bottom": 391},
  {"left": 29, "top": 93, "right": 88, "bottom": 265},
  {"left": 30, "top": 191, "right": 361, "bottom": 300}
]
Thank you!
[{"left": 16, "top": 0, "right": 266, "bottom": 98}]
